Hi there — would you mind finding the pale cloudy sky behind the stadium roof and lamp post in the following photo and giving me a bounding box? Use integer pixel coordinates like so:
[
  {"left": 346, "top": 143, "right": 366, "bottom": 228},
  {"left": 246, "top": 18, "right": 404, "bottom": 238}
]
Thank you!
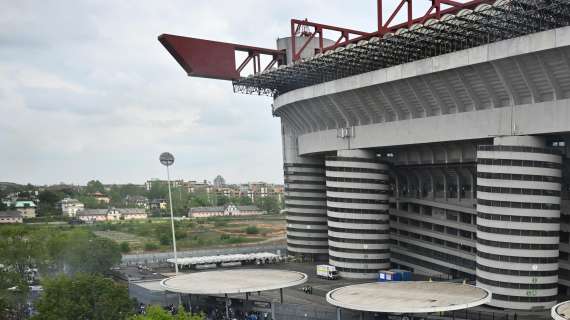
[{"left": 0, "top": 0, "right": 428, "bottom": 185}]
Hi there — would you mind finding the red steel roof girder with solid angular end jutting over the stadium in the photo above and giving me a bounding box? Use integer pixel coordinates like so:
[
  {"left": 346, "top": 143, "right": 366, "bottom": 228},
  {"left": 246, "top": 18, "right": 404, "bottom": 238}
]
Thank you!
[{"left": 158, "top": 0, "right": 488, "bottom": 80}]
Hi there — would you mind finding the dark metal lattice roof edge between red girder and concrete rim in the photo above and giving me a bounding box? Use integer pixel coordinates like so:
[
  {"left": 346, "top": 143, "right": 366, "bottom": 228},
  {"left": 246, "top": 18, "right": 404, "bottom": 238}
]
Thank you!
[{"left": 233, "top": 0, "right": 570, "bottom": 97}]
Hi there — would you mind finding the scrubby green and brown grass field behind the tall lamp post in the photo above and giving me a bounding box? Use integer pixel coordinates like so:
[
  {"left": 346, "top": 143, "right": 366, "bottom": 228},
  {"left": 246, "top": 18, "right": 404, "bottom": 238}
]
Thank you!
[{"left": 87, "top": 215, "right": 285, "bottom": 252}]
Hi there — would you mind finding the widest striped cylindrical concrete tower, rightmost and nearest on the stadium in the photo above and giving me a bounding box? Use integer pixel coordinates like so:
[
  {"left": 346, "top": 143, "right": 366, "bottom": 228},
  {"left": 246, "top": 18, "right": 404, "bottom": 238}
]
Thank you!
[{"left": 477, "top": 137, "right": 562, "bottom": 309}]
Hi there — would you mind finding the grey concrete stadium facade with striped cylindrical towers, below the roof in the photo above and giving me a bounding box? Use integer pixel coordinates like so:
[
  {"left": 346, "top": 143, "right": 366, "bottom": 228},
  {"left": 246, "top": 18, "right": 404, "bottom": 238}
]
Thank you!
[{"left": 280, "top": 27, "right": 570, "bottom": 309}]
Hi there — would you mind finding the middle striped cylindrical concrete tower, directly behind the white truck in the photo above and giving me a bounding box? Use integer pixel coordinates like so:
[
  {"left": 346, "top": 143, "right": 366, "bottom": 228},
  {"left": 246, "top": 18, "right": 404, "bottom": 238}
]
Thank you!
[{"left": 326, "top": 150, "right": 390, "bottom": 279}]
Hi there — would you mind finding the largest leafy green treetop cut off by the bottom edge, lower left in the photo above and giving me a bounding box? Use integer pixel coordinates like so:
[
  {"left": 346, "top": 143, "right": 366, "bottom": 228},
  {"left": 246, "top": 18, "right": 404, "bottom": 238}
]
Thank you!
[{"left": 32, "top": 274, "right": 135, "bottom": 320}]
